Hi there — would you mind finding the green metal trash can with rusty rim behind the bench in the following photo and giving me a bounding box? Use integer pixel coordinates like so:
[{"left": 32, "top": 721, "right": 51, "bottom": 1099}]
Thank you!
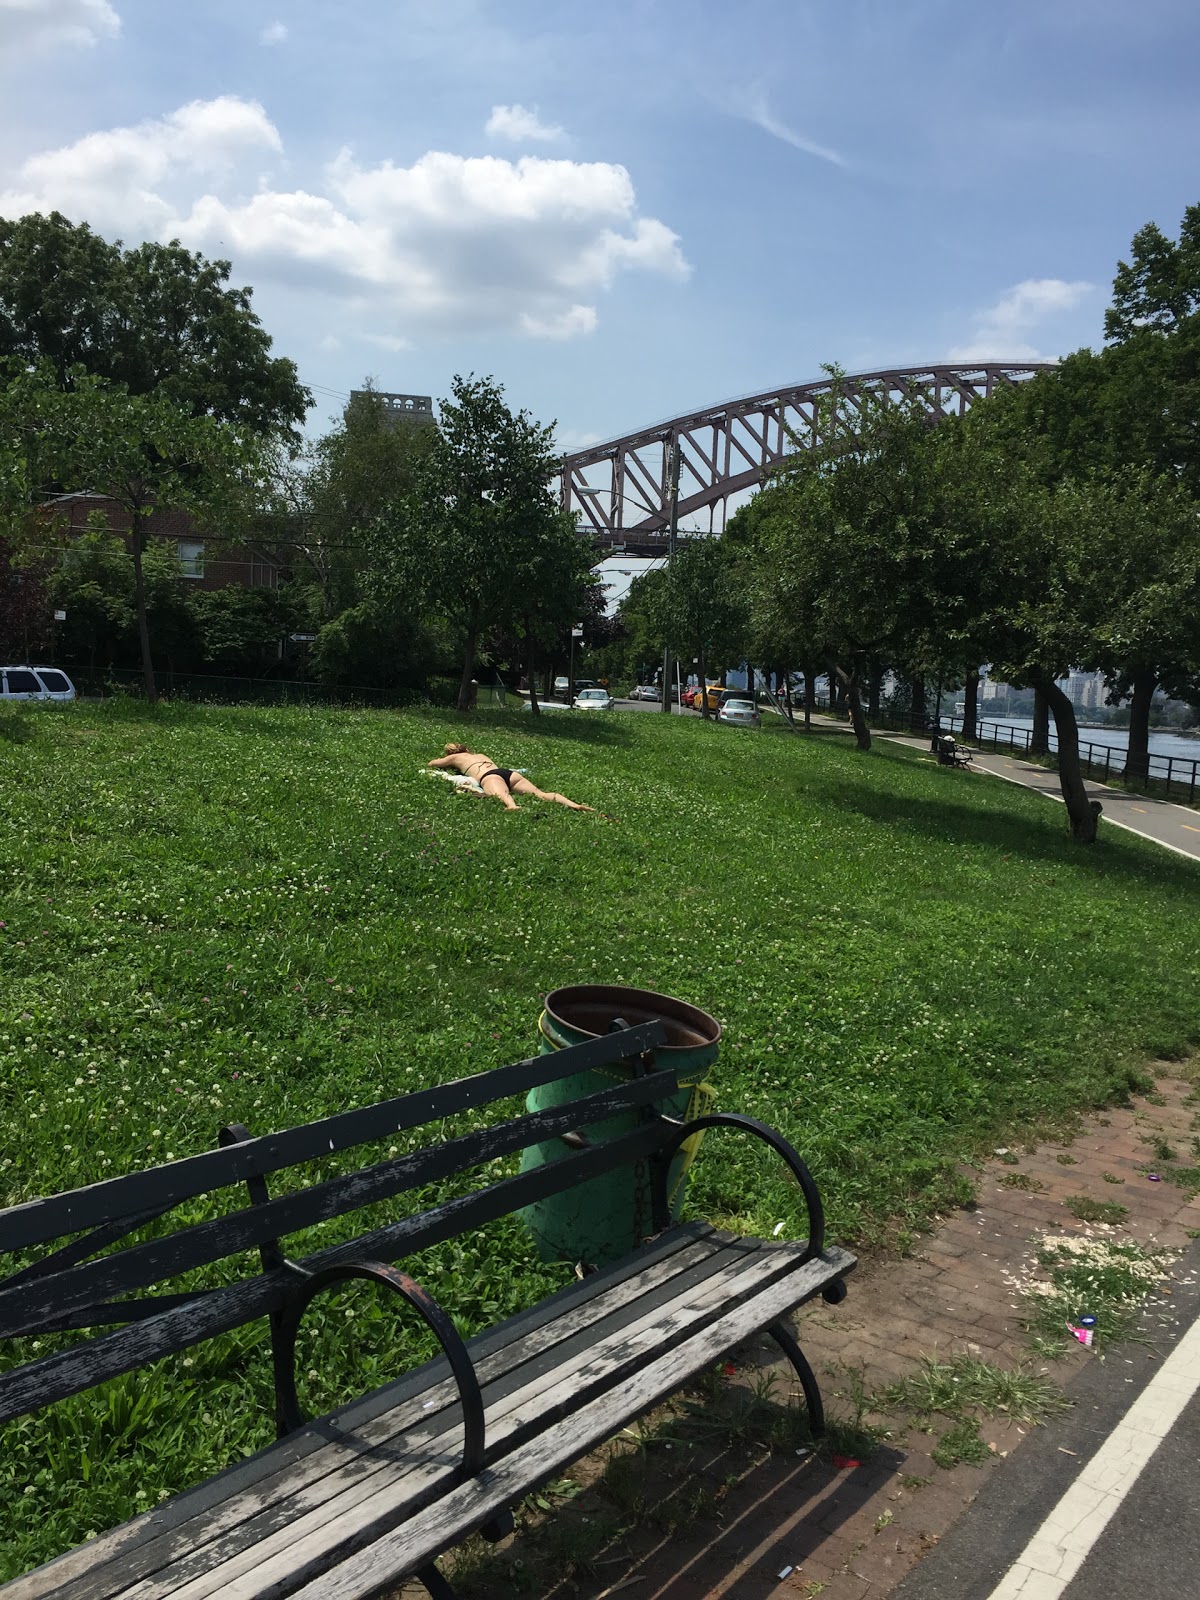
[{"left": 522, "top": 984, "right": 722, "bottom": 1267}]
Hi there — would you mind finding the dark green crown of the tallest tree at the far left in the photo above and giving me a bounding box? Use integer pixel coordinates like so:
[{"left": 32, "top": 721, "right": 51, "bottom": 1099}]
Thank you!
[{"left": 0, "top": 211, "right": 312, "bottom": 440}]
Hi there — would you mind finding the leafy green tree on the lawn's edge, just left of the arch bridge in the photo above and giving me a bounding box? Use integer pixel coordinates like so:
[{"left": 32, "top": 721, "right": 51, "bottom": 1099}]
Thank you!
[{"left": 385, "top": 376, "right": 562, "bottom": 710}]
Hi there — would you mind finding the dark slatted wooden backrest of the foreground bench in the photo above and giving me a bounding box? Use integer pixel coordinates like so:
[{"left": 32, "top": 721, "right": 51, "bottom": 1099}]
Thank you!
[{"left": 0, "top": 1022, "right": 677, "bottom": 1422}]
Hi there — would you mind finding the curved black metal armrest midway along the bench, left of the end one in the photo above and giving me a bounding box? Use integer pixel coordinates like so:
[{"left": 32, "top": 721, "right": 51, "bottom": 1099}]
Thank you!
[{"left": 272, "top": 1261, "right": 483, "bottom": 1480}]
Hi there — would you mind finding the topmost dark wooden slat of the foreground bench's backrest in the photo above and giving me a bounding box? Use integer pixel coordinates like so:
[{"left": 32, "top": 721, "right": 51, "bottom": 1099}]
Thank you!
[{"left": 0, "top": 1022, "right": 666, "bottom": 1251}]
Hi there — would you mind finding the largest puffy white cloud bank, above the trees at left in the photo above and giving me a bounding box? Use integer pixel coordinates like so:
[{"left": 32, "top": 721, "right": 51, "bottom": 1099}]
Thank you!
[{"left": 0, "top": 96, "right": 690, "bottom": 340}]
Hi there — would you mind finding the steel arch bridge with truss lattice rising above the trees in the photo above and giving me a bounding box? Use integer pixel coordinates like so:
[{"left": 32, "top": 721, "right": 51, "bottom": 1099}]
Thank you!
[{"left": 560, "top": 362, "right": 1054, "bottom": 555}]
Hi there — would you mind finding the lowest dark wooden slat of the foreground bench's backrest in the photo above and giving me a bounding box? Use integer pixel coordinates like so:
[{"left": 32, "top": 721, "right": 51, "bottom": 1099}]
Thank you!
[{"left": 0, "top": 1125, "right": 672, "bottom": 1422}]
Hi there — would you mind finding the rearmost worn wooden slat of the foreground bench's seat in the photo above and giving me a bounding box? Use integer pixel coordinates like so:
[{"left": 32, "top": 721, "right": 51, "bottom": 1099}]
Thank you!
[{"left": 11, "top": 1224, "right": 714, "bottom": 1600}]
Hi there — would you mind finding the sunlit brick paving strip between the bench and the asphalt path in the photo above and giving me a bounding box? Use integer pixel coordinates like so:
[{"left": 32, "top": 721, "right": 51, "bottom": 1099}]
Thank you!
[{"left": 742, "top": 1067, "right": 1200, "bottom": 1600}]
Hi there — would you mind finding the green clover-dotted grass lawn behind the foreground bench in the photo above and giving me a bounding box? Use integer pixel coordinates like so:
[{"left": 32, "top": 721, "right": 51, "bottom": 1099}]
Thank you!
[{"left": 0, "top": 701, "right": 1200, "bottom": 1578}]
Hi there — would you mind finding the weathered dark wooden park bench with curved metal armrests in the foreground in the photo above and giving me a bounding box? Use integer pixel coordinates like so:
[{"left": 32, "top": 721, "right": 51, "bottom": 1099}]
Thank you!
[{"left": 0, "top": 1022, "right": 854, "bottom": 1600}]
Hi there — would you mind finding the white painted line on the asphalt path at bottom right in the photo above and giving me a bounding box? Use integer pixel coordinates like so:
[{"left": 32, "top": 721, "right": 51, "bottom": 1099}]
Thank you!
[{"left": 989, "top": 1322, "right": 1200, "bottom": 1600}]
